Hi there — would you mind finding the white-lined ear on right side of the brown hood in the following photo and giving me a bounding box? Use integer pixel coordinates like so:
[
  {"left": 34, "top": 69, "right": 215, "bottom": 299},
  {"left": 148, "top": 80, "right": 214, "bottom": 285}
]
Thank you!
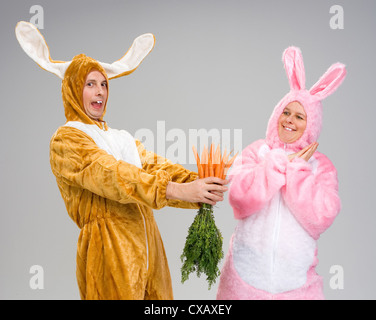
[{"left": 100, "top": 33, "right": 155, "bottom": 79}]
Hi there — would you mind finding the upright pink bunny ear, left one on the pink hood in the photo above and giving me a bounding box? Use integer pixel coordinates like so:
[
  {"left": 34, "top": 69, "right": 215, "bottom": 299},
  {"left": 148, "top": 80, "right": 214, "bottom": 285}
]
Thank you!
[{"left": 282, "top": 47, "right": 305, "bottom": 90}]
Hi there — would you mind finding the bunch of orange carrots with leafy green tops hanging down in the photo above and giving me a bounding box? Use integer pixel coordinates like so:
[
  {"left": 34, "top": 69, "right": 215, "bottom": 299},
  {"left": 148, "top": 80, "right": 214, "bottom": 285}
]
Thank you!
[{"left": 181, "top": 144, "right": 237, "bottom": 289}]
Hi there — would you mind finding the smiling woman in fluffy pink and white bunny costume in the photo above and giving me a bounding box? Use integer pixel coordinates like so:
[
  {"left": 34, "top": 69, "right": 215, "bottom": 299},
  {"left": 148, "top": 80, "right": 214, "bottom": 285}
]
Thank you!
[{"left": 217, "top": 47, "right": 346, "bottom": 299}]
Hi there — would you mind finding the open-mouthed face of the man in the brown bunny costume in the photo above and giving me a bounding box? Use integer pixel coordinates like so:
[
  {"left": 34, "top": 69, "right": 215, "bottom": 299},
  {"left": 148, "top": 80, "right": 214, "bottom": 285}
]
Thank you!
[{"left": 82, "top": 70, "right": 108, "bottom": 120}]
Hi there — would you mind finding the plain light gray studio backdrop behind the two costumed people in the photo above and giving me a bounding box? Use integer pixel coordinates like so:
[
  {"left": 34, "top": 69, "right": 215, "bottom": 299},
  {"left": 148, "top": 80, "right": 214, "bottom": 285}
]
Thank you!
[{"left": 0, "top": 0, "right": 376, "bottom": 299}]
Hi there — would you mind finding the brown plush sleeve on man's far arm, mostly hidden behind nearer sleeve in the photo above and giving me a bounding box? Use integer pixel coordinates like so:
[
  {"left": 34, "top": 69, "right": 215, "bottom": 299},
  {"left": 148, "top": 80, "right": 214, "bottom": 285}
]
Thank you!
[{"left": 135, "top": 140, "right": 199, "bottom": 209}]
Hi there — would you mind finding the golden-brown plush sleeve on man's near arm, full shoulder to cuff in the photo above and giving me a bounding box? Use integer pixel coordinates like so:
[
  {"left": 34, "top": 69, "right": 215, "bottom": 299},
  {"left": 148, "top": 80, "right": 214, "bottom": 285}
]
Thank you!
[{"left": 50, "top": 127, "right": 171, "bottom": 209}]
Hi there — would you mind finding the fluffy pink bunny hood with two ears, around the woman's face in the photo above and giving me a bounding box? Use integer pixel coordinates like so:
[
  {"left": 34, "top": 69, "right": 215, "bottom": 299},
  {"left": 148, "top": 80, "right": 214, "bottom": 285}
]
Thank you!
[{"left": 266, "top": 47, "right": 346, "bottom": 152}]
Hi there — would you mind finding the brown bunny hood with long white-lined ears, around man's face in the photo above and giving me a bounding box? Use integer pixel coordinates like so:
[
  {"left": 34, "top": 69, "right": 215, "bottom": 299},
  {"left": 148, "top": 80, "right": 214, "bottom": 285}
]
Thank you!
[{"left": 15, "top": 21, "right": 155, "bottom": 129}]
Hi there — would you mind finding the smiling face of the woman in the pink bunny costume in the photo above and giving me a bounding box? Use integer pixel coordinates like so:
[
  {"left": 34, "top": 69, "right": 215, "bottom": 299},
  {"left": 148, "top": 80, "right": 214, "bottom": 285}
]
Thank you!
[{"left": 278, "top": 101, "right": 307, "bottom": 143}]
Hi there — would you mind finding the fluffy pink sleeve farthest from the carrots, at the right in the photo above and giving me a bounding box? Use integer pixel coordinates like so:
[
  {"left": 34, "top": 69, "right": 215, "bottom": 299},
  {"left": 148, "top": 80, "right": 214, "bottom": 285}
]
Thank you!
[{"left": 285, "top": 152, "right": 341, "bottom": 239}]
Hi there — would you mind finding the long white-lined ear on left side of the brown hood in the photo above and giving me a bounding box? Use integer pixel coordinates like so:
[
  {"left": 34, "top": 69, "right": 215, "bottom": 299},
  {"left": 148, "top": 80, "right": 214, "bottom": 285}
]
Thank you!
[{"left": 16, "top": 21, "right": 71, "bottom": 79}]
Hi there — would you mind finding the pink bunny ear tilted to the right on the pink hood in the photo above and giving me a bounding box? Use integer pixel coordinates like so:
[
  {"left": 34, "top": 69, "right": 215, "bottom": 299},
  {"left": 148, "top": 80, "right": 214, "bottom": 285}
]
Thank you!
[{"left": 309, "top": 63, "right": 346, "bottom": 100}]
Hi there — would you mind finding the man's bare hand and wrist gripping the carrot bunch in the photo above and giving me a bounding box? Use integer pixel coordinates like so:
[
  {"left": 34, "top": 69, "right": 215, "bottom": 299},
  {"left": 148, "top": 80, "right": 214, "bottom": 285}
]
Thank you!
[{"left": 166, "top": 177, "right": 228, "bottom": 205}]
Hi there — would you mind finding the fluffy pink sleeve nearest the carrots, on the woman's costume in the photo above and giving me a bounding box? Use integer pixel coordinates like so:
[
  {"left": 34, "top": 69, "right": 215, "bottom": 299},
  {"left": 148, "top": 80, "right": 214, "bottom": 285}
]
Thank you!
[{"left": 229, "top": 140, "right": 288, "bottom": 219}]
